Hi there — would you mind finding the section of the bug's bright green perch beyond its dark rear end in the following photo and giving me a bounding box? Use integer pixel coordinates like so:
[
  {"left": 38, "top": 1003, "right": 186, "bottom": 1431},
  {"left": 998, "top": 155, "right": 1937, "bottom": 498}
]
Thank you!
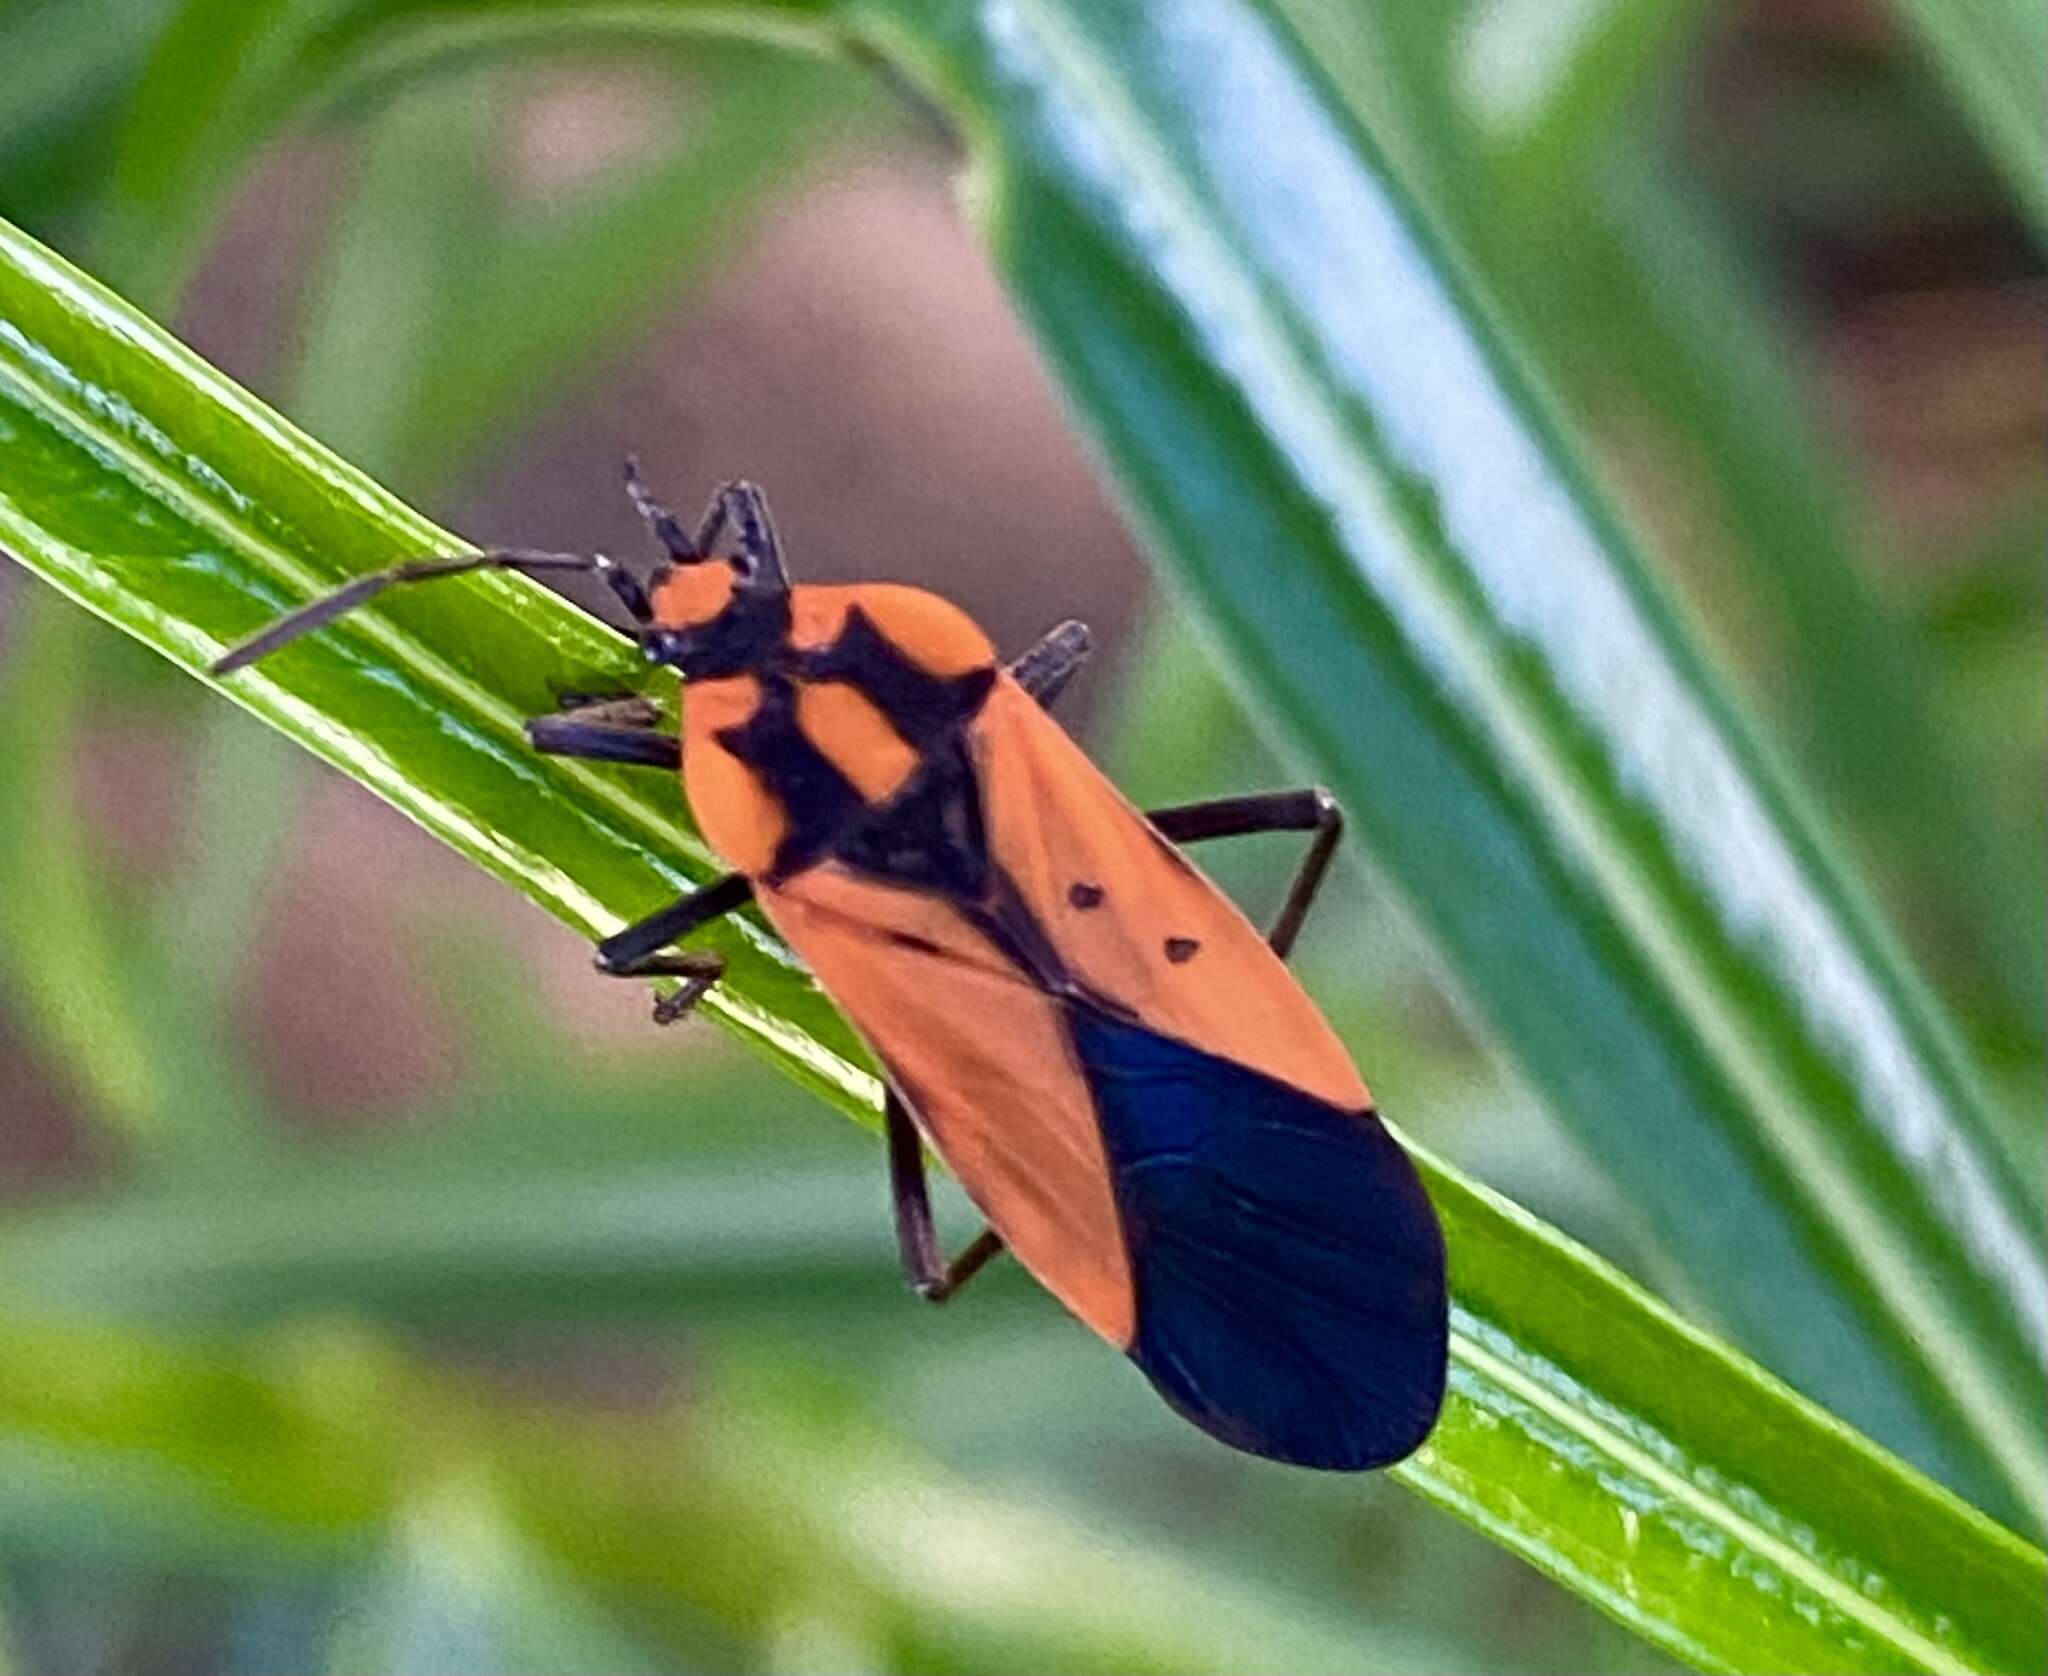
[{"left": 1397, "top": 1174, "right": 2048, "bottom": 1672}]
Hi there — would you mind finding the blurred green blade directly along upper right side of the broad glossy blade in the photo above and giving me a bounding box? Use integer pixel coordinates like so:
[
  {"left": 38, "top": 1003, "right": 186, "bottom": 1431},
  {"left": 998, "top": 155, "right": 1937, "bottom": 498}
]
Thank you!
[{"left": 1280, "top": 0, "right": 2048, "bottom": 1139}]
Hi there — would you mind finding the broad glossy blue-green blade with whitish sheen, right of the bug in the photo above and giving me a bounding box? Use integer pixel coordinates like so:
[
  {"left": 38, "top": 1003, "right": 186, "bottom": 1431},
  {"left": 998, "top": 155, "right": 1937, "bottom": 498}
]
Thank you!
[{"left": 930, "top": 0, "right": 2048, "bottom": 1518}]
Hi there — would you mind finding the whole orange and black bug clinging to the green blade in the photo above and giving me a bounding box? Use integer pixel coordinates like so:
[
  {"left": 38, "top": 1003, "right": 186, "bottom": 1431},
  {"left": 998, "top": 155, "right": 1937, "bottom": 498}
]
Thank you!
[{"left": 215, "top": 467, "right": 1448, "bottom": 1469}]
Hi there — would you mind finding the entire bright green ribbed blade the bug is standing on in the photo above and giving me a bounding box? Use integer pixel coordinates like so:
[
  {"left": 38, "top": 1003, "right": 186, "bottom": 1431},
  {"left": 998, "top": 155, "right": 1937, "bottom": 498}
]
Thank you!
[{"left": 0, "top": 107, "right": 2040, "bottom": 1670}]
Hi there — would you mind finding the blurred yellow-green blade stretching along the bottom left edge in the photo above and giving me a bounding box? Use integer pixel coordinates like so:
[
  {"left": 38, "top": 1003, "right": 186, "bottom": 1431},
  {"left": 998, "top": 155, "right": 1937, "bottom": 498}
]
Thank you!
[{"left": 0, "top": 1319, "right": 1407, "bottom": 1674}]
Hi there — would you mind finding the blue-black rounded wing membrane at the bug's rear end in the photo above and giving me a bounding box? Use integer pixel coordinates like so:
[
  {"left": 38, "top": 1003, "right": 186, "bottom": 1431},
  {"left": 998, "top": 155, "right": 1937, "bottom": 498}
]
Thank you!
[{"left": 1069, "top": 1006, "right": 1448, "bottom": 1469}]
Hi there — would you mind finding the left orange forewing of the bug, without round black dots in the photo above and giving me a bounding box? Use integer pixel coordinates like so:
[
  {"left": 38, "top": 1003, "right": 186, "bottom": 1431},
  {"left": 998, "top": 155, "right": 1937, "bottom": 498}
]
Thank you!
[{"left": 756, "top": 863, "right": 1137, "bottom": 1350}]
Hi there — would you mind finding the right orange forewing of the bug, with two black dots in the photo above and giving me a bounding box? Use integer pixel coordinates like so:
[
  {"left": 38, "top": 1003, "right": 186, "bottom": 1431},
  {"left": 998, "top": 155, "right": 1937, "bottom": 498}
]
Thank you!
[{"left": 971, "top": 676, "right": 1372, "bottom": 1111}]
